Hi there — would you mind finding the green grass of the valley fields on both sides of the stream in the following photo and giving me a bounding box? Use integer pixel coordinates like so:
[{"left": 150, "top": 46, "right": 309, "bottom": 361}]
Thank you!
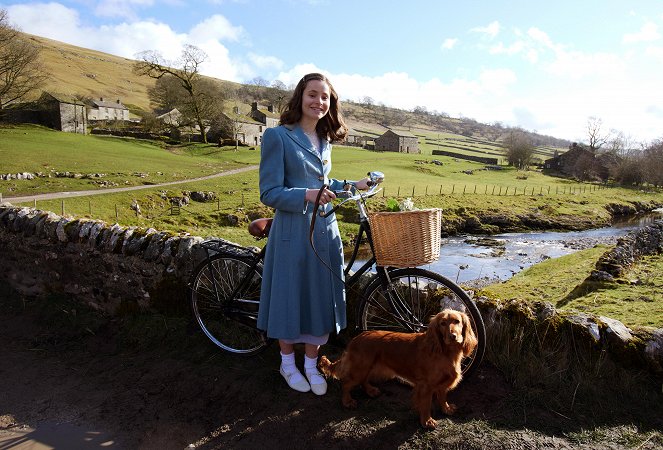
[{"left": 0, "top": 126, "right": 663, "bottom": 326}]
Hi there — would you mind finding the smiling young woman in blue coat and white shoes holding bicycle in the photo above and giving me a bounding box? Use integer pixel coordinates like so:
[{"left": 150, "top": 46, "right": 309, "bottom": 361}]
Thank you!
[{"left": 258, "top": 73, "right": 368, "bottom": 395}]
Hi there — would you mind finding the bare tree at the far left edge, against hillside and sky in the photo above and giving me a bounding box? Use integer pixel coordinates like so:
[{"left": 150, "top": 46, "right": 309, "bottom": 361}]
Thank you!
[{"left": 0, "top": 9, "right": 47, "bottom": 109}]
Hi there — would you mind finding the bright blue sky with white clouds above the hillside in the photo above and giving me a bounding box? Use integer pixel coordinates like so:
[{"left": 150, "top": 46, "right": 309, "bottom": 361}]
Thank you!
[{"left": 0, "top": 0, "right": 663, "bottom": 144}]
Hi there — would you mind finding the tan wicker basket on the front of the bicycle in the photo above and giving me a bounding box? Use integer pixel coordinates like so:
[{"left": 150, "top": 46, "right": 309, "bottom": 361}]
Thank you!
[{"left": 368, "top": 208, "right": 442, "bottom": 267}]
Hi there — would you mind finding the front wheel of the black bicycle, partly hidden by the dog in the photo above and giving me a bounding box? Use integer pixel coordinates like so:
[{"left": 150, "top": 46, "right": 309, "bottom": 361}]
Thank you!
[{"left": 357, "top": 268, "right": 486, "bottom": 376}]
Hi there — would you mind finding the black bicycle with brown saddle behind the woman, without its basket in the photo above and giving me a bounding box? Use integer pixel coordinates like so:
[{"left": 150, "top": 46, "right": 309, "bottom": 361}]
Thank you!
[{"left": 188, "top": 172, "right": 486, "bottom": 375}]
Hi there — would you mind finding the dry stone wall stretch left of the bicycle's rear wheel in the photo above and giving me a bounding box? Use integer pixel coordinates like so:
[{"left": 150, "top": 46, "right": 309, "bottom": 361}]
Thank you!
[{"left": 0, "top": 203, "right": 213, "bottom": 314}]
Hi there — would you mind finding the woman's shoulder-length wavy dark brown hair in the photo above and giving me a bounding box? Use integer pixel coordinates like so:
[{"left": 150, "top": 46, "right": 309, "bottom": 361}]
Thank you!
[{"left": 281, "top": 73, "right": 348, "bottom": 142}]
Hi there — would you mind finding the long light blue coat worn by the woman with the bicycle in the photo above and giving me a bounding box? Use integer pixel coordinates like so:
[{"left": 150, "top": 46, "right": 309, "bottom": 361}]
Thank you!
[{"left": 258, "top": 125, "right": 346, "bottom": 339}]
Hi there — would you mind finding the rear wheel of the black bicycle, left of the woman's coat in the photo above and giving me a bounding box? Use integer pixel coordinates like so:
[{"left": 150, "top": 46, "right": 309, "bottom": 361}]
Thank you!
[{"left": 189, "top": 254, "right": 268, "bottom": 355}]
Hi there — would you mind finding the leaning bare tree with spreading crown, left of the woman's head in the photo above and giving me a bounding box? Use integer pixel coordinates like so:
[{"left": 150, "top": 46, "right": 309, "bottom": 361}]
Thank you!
[{"left": 134, "top": 44, "right": 220, "bottom": 143}]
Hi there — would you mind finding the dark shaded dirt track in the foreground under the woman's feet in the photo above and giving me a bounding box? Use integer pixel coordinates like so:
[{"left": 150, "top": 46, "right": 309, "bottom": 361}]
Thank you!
[{"left": 0, "top": 292, "right": 663, "bottom": 450}]
